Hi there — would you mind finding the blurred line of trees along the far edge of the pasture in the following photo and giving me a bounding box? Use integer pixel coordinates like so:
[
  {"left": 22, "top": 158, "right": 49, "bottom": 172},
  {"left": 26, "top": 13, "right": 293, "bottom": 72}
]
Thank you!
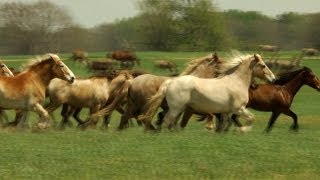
[{"left": 0, "top": 0, "right": 320, "bottom": 54}]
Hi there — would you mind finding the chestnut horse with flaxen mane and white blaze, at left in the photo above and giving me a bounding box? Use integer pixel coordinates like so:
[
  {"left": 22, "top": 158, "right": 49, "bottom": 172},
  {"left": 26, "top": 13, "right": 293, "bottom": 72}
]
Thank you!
[{"left": 0, "top": 54, "right": 75, "bottom": 129}]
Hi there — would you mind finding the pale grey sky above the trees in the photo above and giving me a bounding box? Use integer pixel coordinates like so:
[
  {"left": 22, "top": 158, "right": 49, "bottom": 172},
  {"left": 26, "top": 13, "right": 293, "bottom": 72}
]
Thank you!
[{"left": 0, "top": 0, "right": 320, "bottom": 28}]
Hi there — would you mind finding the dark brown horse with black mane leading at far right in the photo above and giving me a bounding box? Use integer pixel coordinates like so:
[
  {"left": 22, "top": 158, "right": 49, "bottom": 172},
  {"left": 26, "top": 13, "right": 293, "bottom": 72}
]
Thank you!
[{"left": 192, "top": 67, "right": 320, "bottom": 132}]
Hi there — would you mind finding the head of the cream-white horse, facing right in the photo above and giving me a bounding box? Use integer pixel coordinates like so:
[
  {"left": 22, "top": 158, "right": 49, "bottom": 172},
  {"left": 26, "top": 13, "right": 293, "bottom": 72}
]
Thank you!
[{"left": 252, "top": 54, "right": 275, "bottom": 82}]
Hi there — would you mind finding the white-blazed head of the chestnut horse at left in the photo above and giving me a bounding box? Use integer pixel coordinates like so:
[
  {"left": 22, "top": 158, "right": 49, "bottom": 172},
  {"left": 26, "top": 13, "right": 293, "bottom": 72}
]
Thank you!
[{"left": 48, "top": 54, "right": 75, "bottom": 83}]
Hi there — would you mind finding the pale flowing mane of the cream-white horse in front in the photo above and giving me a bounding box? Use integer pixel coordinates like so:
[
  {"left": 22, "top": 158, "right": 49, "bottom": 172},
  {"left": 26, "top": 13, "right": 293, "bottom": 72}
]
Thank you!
[{"left": 217, "top": 51, "right": 252, "bottom": 77}]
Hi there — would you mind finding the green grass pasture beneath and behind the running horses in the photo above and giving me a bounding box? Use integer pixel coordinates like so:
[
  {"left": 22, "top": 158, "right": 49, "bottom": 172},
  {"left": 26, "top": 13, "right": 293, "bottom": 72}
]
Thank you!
[{"left": 0, "top": 51, "right": 320, "bottom": 179}]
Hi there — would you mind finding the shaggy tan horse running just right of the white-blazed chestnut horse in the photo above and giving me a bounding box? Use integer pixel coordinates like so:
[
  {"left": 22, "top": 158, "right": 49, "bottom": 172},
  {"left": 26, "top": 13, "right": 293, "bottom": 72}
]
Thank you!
[{"left": 46, "top": 71, "right": 132, "bottom": 128}]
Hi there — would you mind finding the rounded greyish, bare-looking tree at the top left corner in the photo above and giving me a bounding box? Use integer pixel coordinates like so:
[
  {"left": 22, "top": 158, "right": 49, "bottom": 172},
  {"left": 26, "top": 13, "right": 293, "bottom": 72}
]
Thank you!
[{"left": 0, "top": 1, "right": 73, "bottom": 54}]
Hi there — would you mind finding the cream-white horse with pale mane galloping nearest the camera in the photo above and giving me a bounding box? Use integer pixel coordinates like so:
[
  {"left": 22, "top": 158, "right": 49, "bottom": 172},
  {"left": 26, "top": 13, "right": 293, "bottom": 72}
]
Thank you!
[{"left": 139, "top": 54, "right": 275, "bottom": 131}]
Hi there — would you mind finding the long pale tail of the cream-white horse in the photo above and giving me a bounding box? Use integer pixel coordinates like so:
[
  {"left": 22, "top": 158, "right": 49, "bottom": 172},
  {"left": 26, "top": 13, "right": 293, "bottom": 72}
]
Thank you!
[{"left": 138, "top": 79, "right": 172, "bottom": 128}]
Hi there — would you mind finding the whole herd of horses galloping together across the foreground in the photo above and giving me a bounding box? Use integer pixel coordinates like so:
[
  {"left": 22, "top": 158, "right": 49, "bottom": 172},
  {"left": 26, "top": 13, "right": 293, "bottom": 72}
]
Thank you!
[{"left": 0, "top": 52, "right": 320, "bottom": 132}]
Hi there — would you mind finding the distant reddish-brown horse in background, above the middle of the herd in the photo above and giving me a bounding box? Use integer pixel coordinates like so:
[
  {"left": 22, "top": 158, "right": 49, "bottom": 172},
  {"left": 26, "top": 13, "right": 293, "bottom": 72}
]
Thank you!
[{"left": 107, "top": 50, "right": 140, "bottom": 68}]
